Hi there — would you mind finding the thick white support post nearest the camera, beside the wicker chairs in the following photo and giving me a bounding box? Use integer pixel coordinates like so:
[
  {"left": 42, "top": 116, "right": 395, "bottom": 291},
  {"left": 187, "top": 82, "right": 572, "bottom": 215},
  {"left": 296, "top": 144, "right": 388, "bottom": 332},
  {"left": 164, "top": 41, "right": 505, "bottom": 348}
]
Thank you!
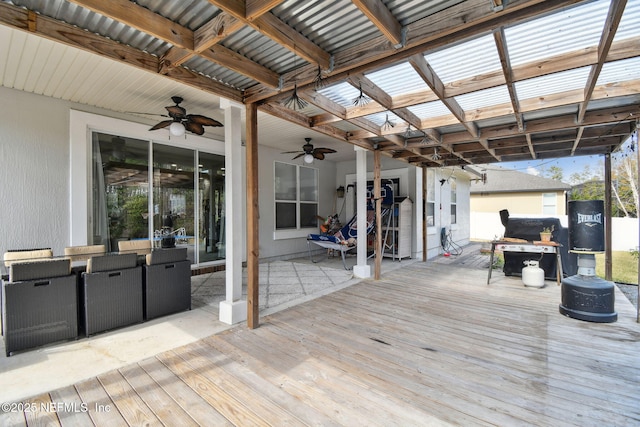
[{"left": 219, "top": 99, "right": 247, "bottom": 325}]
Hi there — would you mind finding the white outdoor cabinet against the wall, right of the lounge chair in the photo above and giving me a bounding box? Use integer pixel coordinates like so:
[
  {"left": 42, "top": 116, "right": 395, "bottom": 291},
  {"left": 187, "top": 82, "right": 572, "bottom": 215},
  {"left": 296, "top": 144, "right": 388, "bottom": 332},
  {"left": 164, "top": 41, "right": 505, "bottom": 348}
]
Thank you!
[{"left": 383, "top": 197, "right": 413, "bottom": 260}]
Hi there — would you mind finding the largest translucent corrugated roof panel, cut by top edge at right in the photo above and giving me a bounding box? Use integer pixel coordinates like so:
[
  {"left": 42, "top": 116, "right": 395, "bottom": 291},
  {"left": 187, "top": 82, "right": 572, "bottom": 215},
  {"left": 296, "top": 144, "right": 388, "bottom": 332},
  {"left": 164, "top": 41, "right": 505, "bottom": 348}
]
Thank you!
[{"left": 505, "top": 0, "right": 610, "bottom": 66}]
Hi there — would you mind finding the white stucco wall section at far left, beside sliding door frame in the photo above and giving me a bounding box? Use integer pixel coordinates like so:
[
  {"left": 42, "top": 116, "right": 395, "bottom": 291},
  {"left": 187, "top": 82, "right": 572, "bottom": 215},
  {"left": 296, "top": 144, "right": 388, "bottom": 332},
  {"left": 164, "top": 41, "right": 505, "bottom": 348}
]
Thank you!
[{"left": 0, "top": 87, "right": 69, "bottom": 253}]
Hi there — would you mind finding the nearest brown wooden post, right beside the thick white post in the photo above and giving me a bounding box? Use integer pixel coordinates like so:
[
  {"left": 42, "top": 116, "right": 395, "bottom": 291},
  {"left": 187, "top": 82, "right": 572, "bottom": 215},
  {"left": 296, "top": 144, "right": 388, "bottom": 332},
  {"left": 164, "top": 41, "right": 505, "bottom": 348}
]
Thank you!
[{"left": 246, "top": 103, "right": 260, "bottom": 329}]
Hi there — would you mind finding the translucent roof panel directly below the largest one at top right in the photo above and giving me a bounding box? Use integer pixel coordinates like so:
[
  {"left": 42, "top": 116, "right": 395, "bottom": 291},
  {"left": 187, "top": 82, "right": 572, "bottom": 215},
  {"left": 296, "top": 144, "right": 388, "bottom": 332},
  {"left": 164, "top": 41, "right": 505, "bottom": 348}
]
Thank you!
[{"left": 515, "top": 67, "right": 591, "bottom": 100}]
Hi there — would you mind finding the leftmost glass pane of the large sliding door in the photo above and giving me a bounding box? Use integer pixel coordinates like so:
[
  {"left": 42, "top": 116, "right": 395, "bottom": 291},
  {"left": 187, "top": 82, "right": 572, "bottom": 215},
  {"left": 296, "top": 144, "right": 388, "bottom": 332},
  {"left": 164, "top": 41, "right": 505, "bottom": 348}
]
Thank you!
[{"left": 90, "top": 132, "right": 149, "bottom": 251}]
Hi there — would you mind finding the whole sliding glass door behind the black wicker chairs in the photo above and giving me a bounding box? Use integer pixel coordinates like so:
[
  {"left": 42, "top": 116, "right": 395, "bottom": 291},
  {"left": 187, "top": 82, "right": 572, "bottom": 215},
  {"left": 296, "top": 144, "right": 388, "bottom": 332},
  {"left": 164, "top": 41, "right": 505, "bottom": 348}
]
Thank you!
[{"left": 89, "top": 132, "right": 225, "bottom": 264}]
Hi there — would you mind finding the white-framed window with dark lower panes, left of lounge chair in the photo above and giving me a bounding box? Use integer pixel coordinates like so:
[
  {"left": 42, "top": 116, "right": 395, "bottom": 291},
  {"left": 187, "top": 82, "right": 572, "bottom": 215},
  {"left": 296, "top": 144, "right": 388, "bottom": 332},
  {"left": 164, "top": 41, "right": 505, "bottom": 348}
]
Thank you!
[{"left": 274, "top": 162, "right": 318, "bottom": 238}]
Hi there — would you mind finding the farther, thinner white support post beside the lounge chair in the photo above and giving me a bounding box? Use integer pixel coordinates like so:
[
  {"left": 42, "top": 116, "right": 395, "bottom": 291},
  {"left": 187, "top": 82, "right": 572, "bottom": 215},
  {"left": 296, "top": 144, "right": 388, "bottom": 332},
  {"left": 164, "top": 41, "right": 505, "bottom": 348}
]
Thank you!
[{"left": 353, "top": 147, "right": 371, "bottom": 279}]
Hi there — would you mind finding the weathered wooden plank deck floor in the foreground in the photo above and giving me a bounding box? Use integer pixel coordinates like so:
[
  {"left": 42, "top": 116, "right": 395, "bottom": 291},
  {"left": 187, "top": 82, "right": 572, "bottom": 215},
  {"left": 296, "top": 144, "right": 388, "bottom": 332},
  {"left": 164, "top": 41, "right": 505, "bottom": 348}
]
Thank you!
[{"left": 0, "top": 263, "right": 640, "bottom": 426}]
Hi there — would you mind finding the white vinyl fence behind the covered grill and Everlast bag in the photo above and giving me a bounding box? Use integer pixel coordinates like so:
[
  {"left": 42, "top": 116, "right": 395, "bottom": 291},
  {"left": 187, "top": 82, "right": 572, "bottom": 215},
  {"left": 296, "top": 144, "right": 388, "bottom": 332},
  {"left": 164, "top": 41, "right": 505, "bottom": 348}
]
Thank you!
[{"left": 470, "top": 212, "right": 639, "bottom": 251}]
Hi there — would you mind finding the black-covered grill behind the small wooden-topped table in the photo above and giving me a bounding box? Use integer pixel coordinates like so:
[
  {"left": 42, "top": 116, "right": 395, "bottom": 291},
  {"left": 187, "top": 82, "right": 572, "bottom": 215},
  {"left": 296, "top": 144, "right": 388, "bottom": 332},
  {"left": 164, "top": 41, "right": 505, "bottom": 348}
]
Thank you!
[{"left": 503, "top": 217, "right": 578, "bottom": 280}]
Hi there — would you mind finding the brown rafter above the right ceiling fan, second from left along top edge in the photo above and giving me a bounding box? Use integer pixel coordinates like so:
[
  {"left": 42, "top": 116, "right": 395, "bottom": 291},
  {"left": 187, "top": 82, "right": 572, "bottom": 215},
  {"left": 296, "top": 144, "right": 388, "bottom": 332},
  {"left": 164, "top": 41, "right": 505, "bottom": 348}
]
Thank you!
[{"left": 209, "top": 0, "right": 331, "bottom": 69}]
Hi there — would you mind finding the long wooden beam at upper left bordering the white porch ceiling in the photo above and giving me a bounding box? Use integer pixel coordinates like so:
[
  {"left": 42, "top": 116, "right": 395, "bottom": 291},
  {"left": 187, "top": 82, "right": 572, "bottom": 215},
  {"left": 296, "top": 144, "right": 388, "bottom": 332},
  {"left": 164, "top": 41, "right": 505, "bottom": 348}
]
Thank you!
[{"left": 0, "top": 3, "right": 242, "bottom": 102}]
